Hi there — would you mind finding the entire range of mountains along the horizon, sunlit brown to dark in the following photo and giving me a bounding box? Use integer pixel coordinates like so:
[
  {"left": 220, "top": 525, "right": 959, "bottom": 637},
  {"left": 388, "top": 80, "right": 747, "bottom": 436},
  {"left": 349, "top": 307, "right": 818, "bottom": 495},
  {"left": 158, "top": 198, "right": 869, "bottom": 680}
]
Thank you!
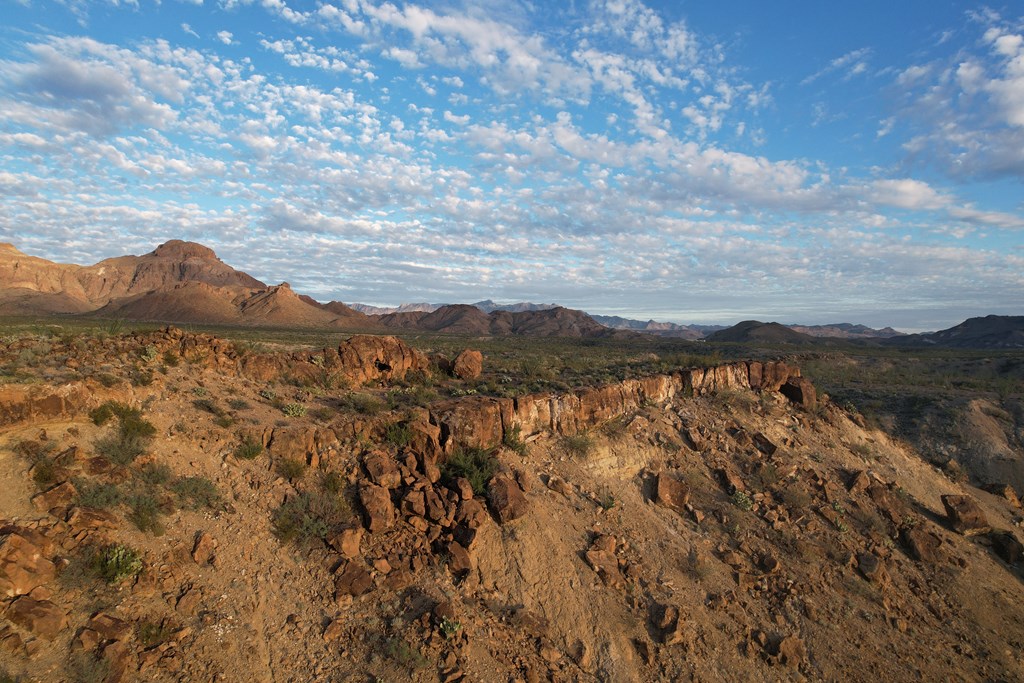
[{"left": 0, "top": 240, "right": 1024, "bottom": 348}]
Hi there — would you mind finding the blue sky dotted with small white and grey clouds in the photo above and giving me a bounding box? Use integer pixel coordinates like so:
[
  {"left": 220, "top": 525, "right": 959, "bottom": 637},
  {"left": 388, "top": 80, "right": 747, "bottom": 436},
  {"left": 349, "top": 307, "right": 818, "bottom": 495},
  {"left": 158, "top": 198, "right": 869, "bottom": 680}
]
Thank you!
[{"left": 0, "top": 0, "right": 1024, "bottom": 331}]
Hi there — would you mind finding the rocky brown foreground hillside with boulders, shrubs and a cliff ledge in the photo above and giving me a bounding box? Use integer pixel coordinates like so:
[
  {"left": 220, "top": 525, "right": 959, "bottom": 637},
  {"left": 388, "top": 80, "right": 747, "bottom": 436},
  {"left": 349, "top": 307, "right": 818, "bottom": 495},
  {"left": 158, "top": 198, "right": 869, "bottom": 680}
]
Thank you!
[{"left": 0, "top": 329, "right": 1024, "bottom": 681}]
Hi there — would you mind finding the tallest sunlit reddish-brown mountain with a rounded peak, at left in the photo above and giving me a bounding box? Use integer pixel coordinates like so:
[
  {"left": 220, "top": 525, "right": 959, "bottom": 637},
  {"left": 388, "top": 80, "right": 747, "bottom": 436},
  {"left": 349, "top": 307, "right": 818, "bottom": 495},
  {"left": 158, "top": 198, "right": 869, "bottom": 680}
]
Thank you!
[{"left": 0, "top": 240, "right": 379, "bottom": 330}]
